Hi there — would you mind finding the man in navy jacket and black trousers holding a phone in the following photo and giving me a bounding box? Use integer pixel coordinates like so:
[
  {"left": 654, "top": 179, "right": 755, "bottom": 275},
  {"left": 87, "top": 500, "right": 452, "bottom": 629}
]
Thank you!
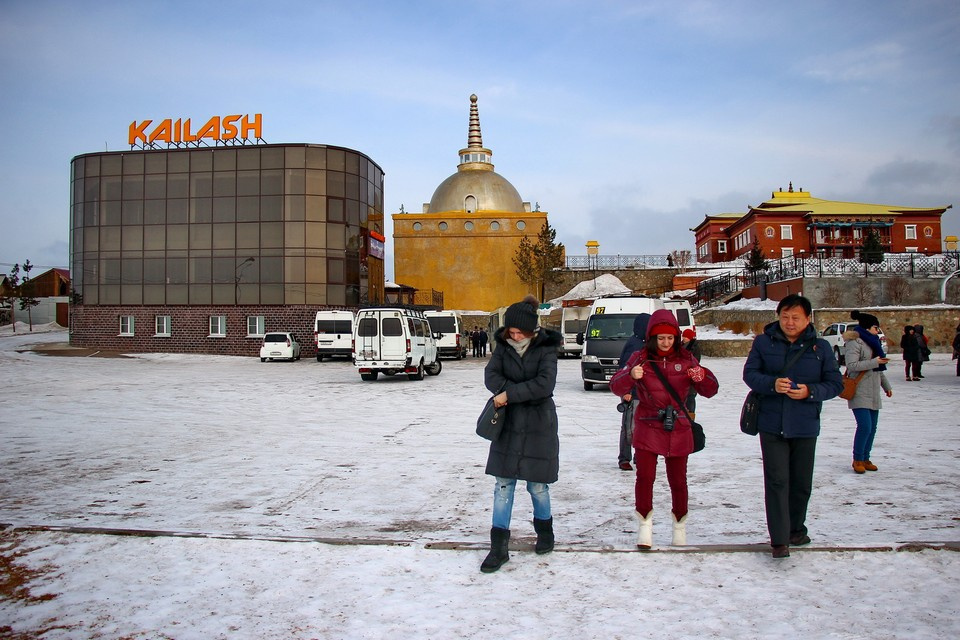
[{"left": 743, "top": 294, "right": 843, "bottom": 558}]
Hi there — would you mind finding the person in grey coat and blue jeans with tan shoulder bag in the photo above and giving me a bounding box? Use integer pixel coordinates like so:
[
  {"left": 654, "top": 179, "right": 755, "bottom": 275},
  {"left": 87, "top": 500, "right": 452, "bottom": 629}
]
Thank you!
[{"left": 843, "top": 311, "right": 893, "bottom": 473}]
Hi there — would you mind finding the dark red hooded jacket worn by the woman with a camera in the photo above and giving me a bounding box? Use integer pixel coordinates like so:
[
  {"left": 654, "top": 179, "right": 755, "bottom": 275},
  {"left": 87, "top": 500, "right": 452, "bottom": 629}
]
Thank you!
[{"left": 610, "top": 309, "right": 719, "bottom": 457}]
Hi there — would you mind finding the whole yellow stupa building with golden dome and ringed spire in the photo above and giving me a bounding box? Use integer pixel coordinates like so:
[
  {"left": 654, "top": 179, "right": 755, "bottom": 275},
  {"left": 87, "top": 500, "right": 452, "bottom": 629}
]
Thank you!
[{"left": 391, "top": 95, "right": 547, "bottom": 311}]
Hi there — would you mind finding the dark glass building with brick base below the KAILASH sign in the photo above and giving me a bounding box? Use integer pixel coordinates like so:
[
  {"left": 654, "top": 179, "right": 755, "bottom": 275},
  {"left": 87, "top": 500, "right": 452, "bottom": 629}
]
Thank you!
[{"left": 70, "top": 144, "right": 383, "bottom": 355}]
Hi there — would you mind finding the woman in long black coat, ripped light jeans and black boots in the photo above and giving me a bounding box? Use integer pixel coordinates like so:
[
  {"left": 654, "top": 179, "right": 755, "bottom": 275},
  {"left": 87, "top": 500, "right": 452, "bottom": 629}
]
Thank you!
[{"left": 480, "top": 296, "right": 563, "bottom": 573}]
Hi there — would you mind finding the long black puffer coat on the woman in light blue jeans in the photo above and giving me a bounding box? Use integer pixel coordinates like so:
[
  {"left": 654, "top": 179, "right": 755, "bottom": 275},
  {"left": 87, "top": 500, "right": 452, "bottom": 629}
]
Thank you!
[{"left": 484, "top": 327, "right": 563, "bottom": 484}]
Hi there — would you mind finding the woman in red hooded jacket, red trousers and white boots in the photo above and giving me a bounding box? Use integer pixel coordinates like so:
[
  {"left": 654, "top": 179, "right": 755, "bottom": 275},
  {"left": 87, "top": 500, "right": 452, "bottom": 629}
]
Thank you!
[{"left": 610, "top": 309, "right": 719, "bottom": 549}]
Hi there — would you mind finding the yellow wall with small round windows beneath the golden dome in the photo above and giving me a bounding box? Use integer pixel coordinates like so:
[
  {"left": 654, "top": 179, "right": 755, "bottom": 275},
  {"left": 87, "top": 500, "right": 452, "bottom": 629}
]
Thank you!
[{"left": 391, "top": 211, "right": 547, "bottom": 311}]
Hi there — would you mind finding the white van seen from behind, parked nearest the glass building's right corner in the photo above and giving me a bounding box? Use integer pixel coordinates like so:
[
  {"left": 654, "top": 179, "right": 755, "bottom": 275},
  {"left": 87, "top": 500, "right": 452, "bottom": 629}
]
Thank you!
[{"left": 353, "top": 307, "right": 441, "bottom": 380}]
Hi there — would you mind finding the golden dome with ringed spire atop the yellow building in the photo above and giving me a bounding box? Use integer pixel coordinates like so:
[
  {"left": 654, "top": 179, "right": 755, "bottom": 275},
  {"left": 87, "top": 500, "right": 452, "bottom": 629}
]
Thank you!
[{"left": 428, "top": 95, "right": 524, "bottom": 213}]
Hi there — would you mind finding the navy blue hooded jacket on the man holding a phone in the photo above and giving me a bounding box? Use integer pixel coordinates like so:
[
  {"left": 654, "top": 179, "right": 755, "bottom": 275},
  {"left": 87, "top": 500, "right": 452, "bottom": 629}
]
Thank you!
[{"left": 743, "top": 322, "right": 843, "bottom": 438}]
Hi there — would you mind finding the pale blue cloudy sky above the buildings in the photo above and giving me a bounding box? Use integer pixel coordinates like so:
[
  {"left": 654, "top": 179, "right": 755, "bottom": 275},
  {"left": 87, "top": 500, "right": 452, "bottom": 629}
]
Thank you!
[{"left": 0, "top": 0, "right": 960, "bottom": 277}]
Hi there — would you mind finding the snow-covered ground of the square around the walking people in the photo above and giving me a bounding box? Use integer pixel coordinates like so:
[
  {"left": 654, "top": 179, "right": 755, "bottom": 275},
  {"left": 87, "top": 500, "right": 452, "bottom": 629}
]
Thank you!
[{"left": 0, "top": 332, "right": 960, "bottom": 640}]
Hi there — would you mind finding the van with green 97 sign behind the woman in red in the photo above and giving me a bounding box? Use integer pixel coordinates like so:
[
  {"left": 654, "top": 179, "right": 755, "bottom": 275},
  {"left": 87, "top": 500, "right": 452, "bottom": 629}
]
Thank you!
[{"left": 580, "top": 294, "right": 664, "bottom": 391}]
